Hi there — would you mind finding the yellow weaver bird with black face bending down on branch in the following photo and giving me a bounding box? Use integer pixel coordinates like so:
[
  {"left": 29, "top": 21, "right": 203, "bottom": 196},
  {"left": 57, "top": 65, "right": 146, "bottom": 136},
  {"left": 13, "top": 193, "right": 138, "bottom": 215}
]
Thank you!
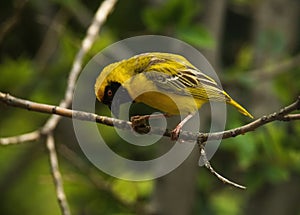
[{"left": 95, "top": 52, "right": 253, "bottom": 140}]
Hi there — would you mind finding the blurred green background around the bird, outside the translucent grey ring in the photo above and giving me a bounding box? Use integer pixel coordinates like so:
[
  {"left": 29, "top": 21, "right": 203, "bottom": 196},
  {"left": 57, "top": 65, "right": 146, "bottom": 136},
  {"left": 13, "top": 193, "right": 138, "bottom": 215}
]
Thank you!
[{"left": 0, "top": 0, "right": 300, "bottom": 215}]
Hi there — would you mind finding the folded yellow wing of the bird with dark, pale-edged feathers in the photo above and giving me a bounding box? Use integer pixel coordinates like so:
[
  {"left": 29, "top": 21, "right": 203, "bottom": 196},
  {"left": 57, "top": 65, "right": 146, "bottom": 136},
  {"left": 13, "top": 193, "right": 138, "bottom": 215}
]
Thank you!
[{"left": 143, "top": 58, "right": 229, "bottom": 101}]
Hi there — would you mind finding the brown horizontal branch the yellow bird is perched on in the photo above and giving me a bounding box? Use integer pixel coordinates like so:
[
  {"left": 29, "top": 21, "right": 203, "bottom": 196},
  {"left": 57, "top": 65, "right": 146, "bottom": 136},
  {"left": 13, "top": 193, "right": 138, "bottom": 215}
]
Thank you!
[{"left": 0, "top": 92, "right": 300, "bottom": 145}]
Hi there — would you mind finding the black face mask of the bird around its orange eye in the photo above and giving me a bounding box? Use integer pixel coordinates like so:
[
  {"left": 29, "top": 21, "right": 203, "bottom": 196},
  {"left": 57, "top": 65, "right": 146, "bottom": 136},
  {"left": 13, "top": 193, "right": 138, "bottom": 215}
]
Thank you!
[{"left": 102, "top": 82, "right": 132, "bottom": 117}]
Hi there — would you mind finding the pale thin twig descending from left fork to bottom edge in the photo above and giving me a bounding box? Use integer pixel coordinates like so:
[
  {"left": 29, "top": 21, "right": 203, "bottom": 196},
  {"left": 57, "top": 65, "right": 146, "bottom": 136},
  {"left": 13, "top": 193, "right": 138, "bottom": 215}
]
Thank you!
[{"left": 46, "top": 134, "right": 71, "bottom": 215}]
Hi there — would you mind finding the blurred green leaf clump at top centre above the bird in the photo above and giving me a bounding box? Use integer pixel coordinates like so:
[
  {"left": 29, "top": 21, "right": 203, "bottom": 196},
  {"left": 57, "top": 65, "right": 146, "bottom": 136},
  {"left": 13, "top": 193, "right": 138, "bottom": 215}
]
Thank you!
[{"left": 143, "top": 0, "right": 215, "bottom": 48}]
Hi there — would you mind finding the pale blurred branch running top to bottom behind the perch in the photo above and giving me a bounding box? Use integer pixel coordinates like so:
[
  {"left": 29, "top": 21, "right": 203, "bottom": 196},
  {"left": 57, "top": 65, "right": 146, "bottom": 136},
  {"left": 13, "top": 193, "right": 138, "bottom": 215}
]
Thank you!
[{"left": 41, "top": 0, "right": 117, "bottom": 215}]
